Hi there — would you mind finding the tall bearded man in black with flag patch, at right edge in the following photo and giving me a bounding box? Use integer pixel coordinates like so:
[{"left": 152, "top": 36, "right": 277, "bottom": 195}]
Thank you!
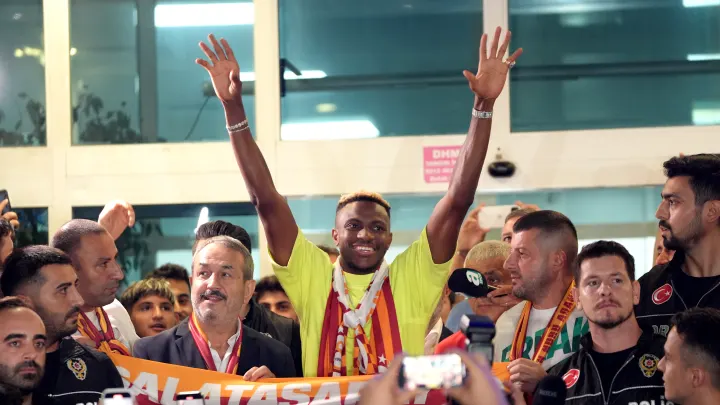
[{"left": 635, "top": 154, "right": 720, "bottom": 336}]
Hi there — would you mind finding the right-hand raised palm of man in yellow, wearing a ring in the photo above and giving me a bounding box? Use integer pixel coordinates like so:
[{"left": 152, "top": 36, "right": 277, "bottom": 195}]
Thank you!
[{"left": 463, "top": 27, "right": 522, "bottom": 99}]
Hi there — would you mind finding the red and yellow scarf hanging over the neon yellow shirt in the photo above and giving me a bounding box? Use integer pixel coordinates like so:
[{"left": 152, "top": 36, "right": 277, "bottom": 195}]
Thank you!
[{"left": 317, "top": 259, "right": 402, "bottom": 377}]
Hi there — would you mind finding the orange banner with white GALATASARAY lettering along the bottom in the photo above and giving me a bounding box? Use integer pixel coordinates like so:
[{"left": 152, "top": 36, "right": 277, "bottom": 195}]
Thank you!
[{"left": 110, "top": 354, "right": 506, "bottom": 405}]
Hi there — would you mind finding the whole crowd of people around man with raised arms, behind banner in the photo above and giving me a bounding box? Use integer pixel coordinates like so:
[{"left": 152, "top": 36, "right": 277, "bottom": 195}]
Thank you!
[{"left": 0, "top": 28, "right": 720, "bottom": 405}]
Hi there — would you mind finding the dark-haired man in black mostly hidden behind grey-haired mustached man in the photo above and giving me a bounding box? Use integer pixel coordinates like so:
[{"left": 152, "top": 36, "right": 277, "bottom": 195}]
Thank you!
[{"left": 193, "top": 220, "right": 302, "bottom": 377}]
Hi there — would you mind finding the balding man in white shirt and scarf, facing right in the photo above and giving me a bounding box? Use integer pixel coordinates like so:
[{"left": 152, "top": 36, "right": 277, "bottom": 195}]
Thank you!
[{"left": 50, "top": 219, "right": 139, "bottom": 355}]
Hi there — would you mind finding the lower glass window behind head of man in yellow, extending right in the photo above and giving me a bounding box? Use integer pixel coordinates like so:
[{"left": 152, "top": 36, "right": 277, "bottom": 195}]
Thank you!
[{"left": 289, "top": 187, "right": 662, "bottom": 277}]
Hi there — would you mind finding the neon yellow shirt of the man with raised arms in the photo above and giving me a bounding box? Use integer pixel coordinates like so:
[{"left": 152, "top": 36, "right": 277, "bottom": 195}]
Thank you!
[{"left": 273, "top": 229, "right": 450, "bottom": 377}]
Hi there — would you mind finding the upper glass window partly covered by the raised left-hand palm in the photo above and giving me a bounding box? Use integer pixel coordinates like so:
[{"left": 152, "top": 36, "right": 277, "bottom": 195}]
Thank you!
[{"left": 70, "top": 0, "right": 254, "bottom": 144}]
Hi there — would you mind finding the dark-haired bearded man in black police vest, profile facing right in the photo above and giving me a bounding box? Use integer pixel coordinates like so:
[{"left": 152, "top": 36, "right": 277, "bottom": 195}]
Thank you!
[{"left": 0, "top": 246, "right": 123, "bottom": 405}]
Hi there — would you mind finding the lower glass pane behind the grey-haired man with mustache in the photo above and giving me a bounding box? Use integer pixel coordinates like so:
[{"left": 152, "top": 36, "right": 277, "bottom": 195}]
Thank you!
[{"left": 73, "top": 203, "right": 260, "bottom": 285}]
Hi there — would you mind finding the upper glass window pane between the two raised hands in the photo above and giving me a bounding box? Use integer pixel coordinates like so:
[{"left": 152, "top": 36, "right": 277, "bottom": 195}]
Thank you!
[{"left": 279, "top": 0, "right": 482, "bottom": 140}]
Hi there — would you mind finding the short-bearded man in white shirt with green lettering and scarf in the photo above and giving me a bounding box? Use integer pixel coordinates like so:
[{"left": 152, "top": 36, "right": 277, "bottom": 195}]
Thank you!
[{"left": 494, "top": 211, "right": 587, "bottom": 393}]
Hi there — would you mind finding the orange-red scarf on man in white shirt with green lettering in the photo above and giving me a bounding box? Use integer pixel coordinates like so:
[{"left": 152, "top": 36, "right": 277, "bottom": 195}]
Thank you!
[{"left": 510, "top": 281, "right": 575, "bottom": 364}]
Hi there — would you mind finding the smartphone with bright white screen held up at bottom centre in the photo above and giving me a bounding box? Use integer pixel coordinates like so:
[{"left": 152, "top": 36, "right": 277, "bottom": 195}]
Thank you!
[{"left": 398, "top": 354, "right": 466, "bottom": 390}]
